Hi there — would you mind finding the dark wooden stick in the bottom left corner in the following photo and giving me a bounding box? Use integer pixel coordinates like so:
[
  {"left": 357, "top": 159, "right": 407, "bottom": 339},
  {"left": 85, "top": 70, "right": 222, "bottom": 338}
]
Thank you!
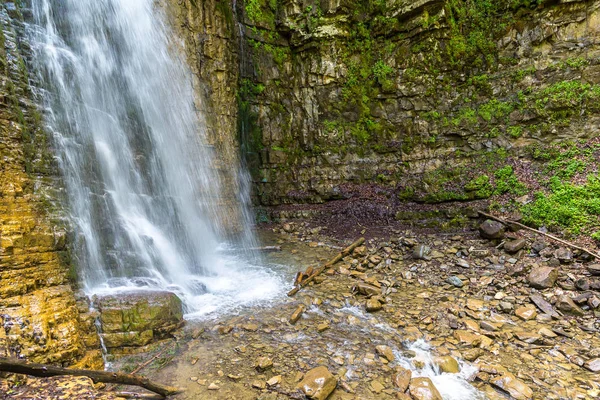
[{"left": 0, "top": 357, "right": 183, "bottom": 397}]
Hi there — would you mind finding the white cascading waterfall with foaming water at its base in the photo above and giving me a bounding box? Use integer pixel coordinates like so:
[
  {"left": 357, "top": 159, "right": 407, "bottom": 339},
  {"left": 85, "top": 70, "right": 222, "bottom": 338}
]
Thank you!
[{"left": 25, "top": 0, "right": 281, "bottom": 315}]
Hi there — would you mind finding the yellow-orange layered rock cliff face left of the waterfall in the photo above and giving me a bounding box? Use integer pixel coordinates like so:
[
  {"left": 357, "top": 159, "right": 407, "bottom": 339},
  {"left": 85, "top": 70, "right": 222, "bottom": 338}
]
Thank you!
[{"left": 0, "top": 1, "right": 102, "bottom": 367}]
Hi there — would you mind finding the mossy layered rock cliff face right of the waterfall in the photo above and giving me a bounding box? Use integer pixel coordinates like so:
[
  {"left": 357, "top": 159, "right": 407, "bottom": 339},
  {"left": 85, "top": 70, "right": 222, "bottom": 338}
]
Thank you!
[{"left": 240, "top": 0, "right": 600, "bottom": 205}]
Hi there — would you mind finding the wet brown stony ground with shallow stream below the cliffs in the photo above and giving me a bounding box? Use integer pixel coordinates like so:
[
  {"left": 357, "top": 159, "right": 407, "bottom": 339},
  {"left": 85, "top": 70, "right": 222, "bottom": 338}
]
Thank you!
[{"left": 3, "top": 217, "right": 600, "bottom": 400}]
